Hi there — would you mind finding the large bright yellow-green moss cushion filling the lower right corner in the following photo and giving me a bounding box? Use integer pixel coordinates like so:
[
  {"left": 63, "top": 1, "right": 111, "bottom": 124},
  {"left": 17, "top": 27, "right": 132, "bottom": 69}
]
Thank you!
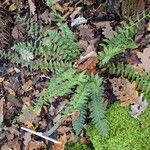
[{"left": 87, "top": 103, "right": 150, "bottom": 150}]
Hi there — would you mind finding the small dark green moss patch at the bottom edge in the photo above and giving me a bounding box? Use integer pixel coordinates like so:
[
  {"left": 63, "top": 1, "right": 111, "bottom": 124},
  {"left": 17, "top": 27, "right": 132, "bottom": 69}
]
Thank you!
[{"left": 65, "top": 141, "right": 92, "bottom": 150}]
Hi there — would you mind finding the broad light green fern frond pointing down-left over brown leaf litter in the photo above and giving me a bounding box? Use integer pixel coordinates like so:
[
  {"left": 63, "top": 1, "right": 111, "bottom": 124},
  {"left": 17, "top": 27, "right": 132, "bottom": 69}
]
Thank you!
[{"left": 34, "top": 68, "right": 87, "bottom": 110}]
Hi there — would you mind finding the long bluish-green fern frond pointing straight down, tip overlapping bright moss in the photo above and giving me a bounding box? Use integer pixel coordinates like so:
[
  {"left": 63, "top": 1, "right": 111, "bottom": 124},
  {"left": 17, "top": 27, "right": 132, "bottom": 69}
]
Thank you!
[{"left": 89, "top": 75, "right": 108, "bottom": 136}]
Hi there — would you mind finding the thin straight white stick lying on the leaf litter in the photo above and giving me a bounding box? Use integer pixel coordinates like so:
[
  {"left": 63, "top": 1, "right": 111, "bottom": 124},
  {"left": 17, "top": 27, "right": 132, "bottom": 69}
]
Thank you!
[{"left": 21, "top": 127, "right": 62, "bottom": 144}]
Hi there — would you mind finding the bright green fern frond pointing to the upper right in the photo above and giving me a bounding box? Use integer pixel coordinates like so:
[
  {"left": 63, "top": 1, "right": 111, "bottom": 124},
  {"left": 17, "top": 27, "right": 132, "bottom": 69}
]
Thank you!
[{"left": 99, "top": 20, "right": 137, "bottom": 65}]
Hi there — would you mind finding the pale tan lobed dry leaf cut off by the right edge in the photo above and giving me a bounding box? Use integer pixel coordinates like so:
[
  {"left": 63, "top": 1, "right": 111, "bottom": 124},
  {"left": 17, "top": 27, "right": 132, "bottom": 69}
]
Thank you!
[{"left": 137, "top": 47, "right": 150, "bottom": 73}]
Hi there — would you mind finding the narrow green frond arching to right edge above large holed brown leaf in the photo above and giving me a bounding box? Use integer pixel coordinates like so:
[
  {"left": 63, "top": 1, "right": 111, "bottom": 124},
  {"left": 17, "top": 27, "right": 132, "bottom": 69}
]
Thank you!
[{"left": 108, "top": 63, "right": 150, "bottom": 97}]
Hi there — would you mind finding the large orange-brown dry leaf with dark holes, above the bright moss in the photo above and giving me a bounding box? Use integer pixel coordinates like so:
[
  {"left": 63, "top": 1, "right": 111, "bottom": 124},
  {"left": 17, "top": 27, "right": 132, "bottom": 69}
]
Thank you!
[{"left": 109, "top": 77, "right": 138, "bottom": 106}]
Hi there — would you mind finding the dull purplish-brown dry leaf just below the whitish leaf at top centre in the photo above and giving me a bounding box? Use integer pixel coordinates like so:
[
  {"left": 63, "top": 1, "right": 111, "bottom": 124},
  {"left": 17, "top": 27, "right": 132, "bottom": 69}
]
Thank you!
[{"left": 79, "top": 25, "right": 94, "bottom": 41}]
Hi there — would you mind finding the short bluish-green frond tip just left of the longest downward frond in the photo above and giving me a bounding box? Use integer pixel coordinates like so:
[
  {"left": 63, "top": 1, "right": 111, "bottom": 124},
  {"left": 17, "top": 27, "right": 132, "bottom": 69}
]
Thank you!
[{"left": 72, "top": 105, "right": 86, "bottom": 135}]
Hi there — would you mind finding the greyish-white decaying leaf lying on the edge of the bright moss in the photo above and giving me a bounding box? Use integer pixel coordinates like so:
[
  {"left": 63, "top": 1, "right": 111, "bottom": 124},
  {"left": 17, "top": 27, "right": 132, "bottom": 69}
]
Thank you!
[{"left": 129, "top": 94, "right": 148, "bottom": 119}]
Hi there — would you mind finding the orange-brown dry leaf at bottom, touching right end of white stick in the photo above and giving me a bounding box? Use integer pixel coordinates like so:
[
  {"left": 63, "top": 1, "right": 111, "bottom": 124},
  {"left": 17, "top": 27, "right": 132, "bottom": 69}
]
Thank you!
[{"left": 52, "top": 133, "right": 67, "bottom": 150}]
